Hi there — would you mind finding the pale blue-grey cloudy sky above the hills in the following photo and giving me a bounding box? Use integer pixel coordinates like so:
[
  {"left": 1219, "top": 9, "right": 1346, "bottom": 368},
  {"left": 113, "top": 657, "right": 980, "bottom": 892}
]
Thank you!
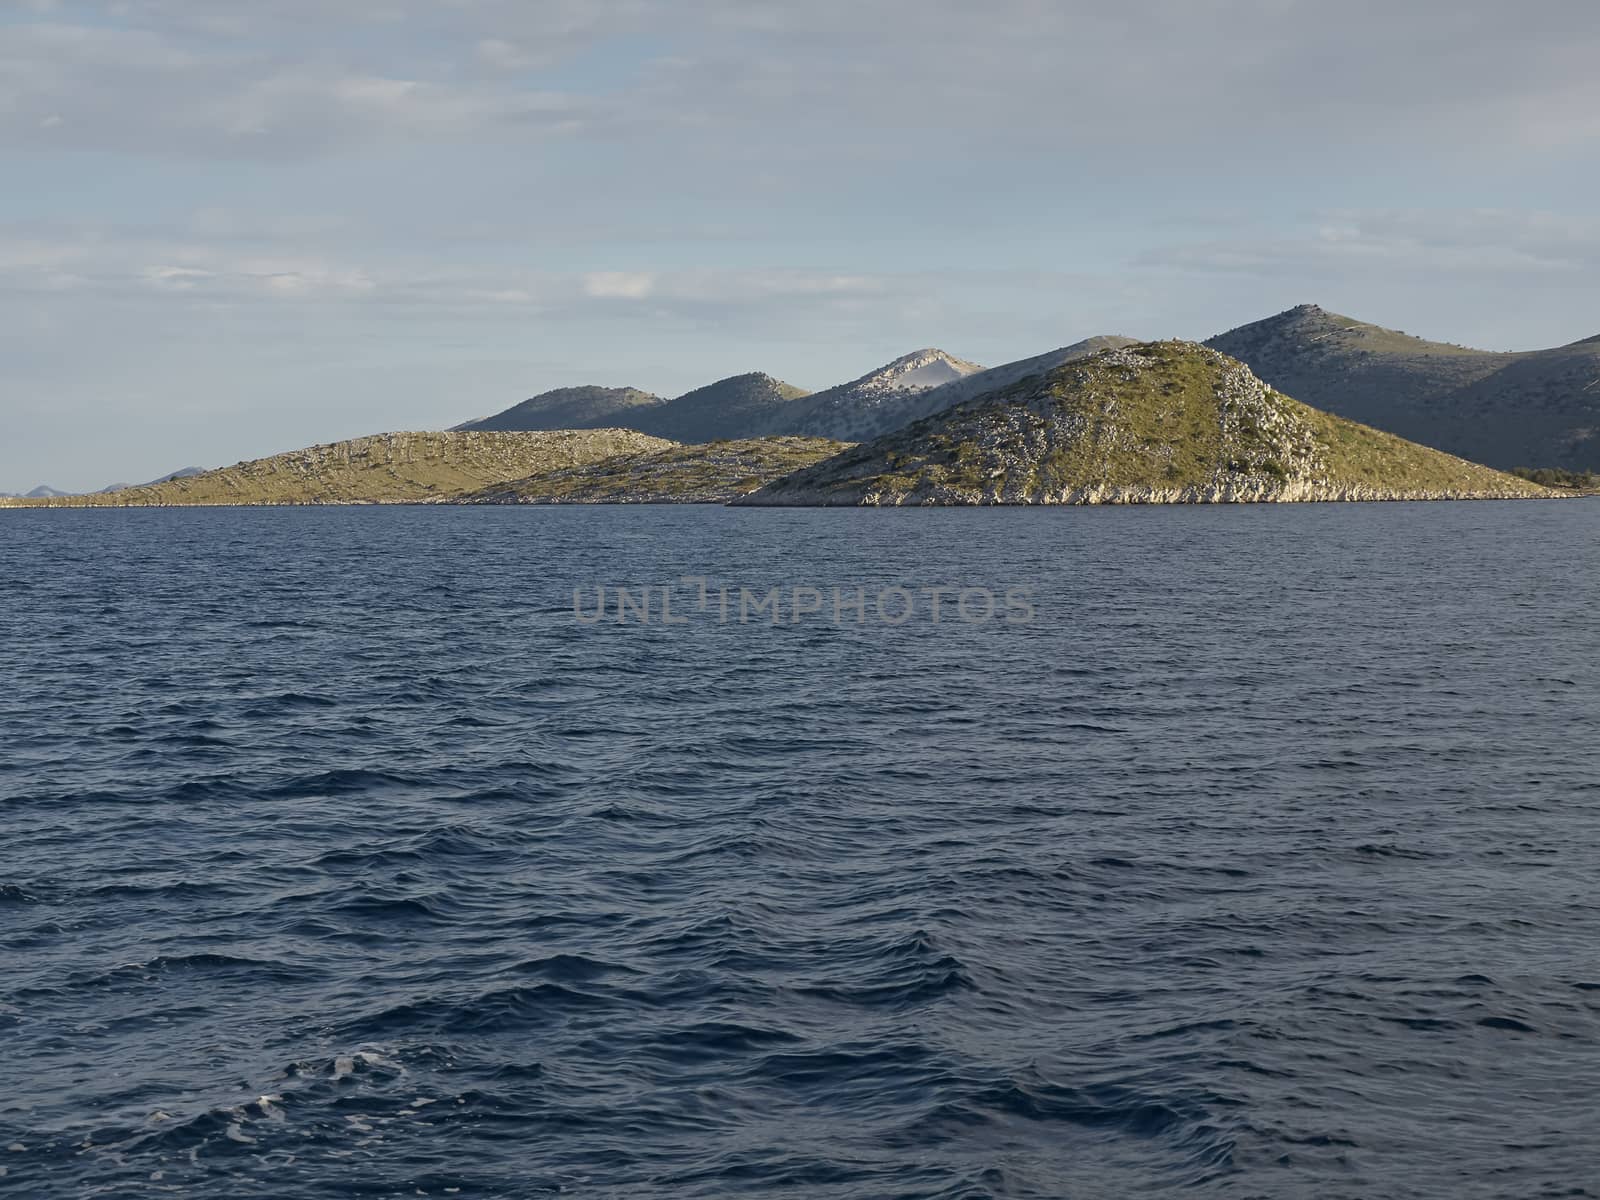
[{"left": 0, "top": 0, "right": 1600, "bottom": 491}]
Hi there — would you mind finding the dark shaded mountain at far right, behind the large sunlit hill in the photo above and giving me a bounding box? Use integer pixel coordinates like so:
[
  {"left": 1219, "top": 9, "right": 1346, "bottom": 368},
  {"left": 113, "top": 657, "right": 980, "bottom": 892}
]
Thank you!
[{"left": 1206, "top": 304, "right": 1600, "bottom": 470}]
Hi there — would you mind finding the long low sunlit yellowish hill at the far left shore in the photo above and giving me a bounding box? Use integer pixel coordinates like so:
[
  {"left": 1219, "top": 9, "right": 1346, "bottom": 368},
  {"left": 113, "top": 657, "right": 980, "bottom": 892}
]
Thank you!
[{"left": 5, "top": 429, "right": 672, "bottom": 507}]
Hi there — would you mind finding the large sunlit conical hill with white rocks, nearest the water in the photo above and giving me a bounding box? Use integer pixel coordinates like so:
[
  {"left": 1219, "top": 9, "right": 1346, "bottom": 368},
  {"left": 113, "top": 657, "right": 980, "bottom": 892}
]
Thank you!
[{"left": 736, "top": 342, "right": 1554, "bottom": 506}]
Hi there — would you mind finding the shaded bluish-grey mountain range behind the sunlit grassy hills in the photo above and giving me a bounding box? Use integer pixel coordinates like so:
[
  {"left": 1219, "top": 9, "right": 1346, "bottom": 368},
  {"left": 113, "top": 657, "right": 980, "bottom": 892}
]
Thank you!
[{"left": 448, "top": 304, "right": 1600, "bottom": 475}]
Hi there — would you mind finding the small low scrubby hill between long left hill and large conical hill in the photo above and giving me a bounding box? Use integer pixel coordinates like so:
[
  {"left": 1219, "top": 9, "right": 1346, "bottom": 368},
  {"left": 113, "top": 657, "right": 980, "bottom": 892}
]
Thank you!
[{"left": 461, "top": 437, "right": 845, "bottom": 504}]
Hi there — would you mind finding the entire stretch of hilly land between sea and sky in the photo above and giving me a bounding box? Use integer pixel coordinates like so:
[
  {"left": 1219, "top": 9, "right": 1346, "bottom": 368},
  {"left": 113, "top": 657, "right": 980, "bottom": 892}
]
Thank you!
[{"left": 12, "top": 304, "right": 1600, "bottom": 507}]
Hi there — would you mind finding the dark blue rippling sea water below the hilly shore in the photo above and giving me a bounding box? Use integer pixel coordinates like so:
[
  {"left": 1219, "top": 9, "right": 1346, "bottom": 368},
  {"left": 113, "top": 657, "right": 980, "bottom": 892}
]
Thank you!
[{"left": 0, "top": 501, "right": 1600, "bottom": 1200}]
